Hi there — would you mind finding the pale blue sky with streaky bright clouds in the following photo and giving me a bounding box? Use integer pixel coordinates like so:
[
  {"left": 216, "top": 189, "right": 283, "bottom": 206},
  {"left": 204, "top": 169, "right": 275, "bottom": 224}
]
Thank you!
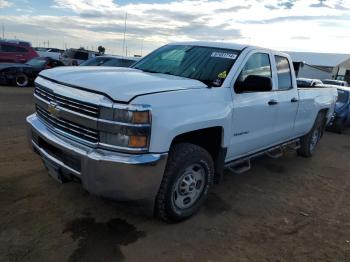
[{"left": 0, "top": 0, "right": 350, "bottom": 55}]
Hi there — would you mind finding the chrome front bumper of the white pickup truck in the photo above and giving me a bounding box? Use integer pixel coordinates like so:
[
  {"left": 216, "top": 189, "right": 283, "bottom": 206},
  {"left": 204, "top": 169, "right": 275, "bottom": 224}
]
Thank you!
[{"left": 26, "top": 114, "right": 167, "bottom": 212}]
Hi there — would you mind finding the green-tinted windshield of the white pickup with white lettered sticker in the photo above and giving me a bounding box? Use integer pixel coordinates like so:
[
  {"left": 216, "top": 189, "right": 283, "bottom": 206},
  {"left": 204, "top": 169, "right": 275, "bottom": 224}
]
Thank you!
[{"left": 133, "top": 45, "right": 239, "bottom": 86}]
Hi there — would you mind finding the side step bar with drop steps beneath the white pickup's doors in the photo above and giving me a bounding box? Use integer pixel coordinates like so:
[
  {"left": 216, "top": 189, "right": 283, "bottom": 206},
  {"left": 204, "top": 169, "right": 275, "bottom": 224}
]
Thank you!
[{"left": 225, "top": 139, "right": 300, "bottom": 174}]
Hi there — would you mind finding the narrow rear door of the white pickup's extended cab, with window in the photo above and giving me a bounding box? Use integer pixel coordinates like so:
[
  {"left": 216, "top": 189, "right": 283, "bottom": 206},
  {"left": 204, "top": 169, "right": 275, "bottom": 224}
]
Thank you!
[{"left": 274, "top": 55, "right": 299, "bottom": 142}]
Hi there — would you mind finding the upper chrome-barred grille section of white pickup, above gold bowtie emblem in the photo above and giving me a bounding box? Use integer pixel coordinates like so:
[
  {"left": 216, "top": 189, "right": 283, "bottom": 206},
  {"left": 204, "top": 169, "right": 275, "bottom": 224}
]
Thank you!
[{"left": 34, "top": 85, "right": 100, "bottom": 118}]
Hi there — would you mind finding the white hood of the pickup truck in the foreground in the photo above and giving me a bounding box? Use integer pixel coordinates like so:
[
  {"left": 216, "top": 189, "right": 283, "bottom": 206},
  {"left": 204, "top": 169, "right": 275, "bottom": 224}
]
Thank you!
[{"left": 40, "top": 66, "right": 207, "bottom": 102}]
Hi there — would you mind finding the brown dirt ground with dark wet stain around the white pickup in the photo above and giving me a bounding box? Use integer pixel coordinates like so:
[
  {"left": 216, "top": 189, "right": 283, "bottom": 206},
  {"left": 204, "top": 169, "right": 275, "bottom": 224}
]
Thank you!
[{"left": 0, "top": 87, "right": 350, "bottom": 262}]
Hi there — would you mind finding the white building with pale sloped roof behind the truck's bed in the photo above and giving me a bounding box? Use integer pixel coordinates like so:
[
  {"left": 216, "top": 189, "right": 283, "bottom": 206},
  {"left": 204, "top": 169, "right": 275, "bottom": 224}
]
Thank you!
[{"left": 286, "top": 52, "right": 350, "bottom": 80}]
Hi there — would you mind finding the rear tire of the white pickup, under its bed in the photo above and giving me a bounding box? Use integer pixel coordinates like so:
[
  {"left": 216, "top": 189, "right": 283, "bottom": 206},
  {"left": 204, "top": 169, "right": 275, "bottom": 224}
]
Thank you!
[{"left": 297, "top": 112, "right": 325, "bottom": 157}]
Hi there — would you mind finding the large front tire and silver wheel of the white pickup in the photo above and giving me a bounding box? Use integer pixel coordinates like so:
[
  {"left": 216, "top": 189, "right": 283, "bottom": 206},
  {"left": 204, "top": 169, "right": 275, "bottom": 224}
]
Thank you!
[{"left": 155, "top": 143, "right": 214, "bottom": 222}]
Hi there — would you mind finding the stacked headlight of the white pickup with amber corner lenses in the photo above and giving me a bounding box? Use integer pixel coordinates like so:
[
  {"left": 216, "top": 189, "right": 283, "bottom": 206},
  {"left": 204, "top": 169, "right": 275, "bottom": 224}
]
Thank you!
[{"left": 100, "top": 105, "right": 152, "bottom": 151}]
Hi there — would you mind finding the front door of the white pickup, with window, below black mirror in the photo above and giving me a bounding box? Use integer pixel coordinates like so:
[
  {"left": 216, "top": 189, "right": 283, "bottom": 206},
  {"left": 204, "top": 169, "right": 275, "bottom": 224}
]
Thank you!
[{"left": 228, "top": 51, "right": 278, "bottom": 160}]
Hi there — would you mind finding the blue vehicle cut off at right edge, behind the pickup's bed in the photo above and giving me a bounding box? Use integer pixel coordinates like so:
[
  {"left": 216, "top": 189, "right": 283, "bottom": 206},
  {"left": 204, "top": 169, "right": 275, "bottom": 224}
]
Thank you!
[{"left": 327, "top": 87, "right": 350, "bottom": 134}]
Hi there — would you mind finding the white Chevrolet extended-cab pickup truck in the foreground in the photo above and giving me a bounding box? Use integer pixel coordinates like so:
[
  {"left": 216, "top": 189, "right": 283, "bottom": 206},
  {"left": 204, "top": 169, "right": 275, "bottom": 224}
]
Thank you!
[{"left": 27, "top": 42, "right": 337, "bottom": 221}]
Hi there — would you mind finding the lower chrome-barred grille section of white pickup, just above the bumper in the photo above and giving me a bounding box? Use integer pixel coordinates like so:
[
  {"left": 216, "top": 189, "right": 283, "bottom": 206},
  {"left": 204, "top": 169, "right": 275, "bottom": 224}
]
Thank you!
[{"left": 36, "top": 105, "right": 99, "bottom": 143}]
